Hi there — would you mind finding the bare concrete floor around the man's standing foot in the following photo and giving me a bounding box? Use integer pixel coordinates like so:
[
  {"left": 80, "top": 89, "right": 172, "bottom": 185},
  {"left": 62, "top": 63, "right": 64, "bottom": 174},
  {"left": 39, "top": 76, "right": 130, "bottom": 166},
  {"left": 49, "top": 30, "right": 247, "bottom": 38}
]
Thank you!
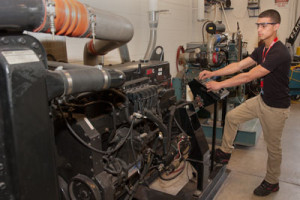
[{"left": 215, "top": 102, "right": 300, "bottom": 200}]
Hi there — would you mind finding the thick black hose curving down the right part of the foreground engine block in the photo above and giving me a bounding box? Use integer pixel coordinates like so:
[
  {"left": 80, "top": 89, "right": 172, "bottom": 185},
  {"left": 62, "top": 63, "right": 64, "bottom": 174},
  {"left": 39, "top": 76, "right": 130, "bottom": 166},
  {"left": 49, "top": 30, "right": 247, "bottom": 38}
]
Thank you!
[{"left": 144, "top": 109, "right": 171, "bottom": 155}]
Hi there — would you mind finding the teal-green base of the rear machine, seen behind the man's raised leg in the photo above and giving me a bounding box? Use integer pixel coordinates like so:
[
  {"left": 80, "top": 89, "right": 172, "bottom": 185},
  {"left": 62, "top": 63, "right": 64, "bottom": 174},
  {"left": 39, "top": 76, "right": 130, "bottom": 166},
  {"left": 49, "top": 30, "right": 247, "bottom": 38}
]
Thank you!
[{"left": 201, "top": 119, "right": 261, "bottom": 146}]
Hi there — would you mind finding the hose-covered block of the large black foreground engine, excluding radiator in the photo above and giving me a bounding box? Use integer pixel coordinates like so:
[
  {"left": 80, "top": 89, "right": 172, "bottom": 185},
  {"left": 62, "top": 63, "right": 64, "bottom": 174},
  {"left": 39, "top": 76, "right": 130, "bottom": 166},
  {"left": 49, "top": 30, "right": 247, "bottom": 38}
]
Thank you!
[{"left": 51, "top": 62, "right": 192, "bottom": 199}]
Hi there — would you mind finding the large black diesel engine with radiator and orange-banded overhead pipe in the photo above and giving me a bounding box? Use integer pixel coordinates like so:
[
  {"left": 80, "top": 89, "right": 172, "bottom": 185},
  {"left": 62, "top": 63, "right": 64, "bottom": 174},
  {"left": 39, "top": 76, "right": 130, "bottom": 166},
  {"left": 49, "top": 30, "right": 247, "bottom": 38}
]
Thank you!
[{"left": 0, "top": 0, "right": 226, "bottom": 200}]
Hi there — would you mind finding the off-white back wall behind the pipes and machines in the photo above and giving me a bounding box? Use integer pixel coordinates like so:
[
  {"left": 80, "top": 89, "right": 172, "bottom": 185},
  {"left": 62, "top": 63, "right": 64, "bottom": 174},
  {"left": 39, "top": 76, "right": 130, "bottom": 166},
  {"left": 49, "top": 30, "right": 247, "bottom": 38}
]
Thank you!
[{"left": 67, "top": 0, "right": 300, "bottom": 76}]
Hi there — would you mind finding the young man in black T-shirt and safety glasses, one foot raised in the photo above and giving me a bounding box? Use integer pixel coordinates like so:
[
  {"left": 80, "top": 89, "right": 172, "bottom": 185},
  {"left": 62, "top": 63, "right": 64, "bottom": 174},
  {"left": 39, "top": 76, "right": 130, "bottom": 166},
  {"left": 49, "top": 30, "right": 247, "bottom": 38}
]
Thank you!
[{"left": 199, "top": 10, "right": 291, "bottom": 196}]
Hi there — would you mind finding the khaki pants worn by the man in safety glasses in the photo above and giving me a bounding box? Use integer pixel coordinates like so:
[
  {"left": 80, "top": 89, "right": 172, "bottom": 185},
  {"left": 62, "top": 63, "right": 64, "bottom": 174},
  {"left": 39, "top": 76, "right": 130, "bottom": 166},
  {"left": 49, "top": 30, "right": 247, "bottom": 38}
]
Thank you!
[{"left": 221, "top": 95, "right": 290, "bottom": 184}]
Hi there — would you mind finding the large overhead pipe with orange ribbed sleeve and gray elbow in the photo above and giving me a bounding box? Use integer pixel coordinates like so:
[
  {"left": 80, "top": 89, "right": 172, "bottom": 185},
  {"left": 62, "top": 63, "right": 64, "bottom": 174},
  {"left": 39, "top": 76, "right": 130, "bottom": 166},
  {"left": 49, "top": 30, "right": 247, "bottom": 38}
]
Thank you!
[{"left": 0, "top": 0, "right": 133, "bottom": 64}]
